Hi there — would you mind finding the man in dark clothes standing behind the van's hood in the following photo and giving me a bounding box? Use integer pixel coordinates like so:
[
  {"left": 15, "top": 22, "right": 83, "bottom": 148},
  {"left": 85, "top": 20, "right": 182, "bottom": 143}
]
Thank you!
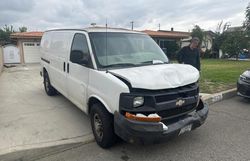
[{"left": 177, "top": 37, "right": 200, "bottom": 71}]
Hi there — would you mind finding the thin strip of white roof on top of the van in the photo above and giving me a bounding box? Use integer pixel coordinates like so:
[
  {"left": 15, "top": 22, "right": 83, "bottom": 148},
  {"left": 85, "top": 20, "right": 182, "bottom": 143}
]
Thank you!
[{"left": 46, "top": 26, "right": 145, "bottom": 34}]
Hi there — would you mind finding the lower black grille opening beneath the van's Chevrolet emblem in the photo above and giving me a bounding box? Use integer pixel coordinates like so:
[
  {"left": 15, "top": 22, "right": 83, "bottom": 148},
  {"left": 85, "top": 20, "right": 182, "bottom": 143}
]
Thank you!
[{"left": 157, "top": 103, "right": 196, "bottom": 118}]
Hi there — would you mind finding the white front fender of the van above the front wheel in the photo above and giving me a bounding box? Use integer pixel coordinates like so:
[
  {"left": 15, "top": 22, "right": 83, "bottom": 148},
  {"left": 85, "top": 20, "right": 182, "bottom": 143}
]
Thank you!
[{"left": 88, "top": 70, "right": 129, "bottom": 114}]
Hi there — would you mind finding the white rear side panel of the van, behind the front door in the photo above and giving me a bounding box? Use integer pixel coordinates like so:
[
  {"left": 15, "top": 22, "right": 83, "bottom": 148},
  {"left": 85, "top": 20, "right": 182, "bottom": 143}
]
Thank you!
[{"left": 41, "top": 31, "right": 74, "bottom": 97}]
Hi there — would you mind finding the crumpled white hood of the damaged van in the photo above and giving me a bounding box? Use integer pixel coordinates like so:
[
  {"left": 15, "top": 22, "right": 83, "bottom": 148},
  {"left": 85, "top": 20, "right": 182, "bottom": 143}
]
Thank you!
[{"left": 109, "top": 64, "right": 200, "bottom": 90}]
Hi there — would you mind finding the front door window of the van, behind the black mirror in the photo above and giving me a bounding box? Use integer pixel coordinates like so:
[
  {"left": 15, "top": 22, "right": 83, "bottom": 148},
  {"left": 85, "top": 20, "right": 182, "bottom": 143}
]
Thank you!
[{"left": 70, "top": 34, "right": 91, "bottom": 66}]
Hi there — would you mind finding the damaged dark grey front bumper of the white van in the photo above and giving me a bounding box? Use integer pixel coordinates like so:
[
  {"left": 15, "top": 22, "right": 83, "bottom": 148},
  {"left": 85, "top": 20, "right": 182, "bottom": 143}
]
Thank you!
[{"left": 114, "top": 100, "right": 209, "bottom": 144}]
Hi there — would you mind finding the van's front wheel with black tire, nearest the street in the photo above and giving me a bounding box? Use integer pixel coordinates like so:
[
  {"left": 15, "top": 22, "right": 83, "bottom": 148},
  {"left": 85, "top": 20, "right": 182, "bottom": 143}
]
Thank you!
[{"left": 90, "top": 103, "right": 117, "bottom": 149}]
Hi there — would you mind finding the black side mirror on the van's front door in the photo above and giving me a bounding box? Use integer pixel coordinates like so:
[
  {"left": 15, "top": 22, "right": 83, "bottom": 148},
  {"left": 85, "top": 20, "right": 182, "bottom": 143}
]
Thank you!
[{"left": 70, "top": 50, "right": 89, "bottom": 65}]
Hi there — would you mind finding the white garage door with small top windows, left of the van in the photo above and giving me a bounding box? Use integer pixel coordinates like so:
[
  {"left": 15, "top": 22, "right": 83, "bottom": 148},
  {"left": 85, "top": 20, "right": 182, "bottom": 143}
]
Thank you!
[{"left": 23, "top": 42, "right": 41, "bottom": 63}]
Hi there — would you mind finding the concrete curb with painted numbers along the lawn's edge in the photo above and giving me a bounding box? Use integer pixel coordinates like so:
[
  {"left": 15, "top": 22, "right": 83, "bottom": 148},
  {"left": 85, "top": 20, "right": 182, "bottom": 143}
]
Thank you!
[{"left": 201, "top": 88, "right": 237, "bottom": 105}]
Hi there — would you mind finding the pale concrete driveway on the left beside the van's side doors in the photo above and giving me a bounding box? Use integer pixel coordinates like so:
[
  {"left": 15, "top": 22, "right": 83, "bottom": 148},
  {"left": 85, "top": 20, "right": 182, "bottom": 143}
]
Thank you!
[{"left": 0, "top": 64, "right": 93, "bottom": 157}]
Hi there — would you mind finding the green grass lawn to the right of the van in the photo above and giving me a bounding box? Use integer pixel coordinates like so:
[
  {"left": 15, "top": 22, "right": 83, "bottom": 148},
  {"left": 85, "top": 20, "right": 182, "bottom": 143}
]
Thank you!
[{"left": 200, "top": 59, "right": 250, "bottom": 93}]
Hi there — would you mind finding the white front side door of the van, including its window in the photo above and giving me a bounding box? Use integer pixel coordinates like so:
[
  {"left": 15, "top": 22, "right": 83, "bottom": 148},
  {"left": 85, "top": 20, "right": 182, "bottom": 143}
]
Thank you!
[{"left": 67, "top": 33, "right": 92, "bottom": 111}]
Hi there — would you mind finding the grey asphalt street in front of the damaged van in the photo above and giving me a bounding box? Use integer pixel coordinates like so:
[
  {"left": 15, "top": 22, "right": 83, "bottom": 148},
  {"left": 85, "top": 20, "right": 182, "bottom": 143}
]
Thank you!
[{"left": 37, "top": 96, "right": 250, "bottom": 161}]
